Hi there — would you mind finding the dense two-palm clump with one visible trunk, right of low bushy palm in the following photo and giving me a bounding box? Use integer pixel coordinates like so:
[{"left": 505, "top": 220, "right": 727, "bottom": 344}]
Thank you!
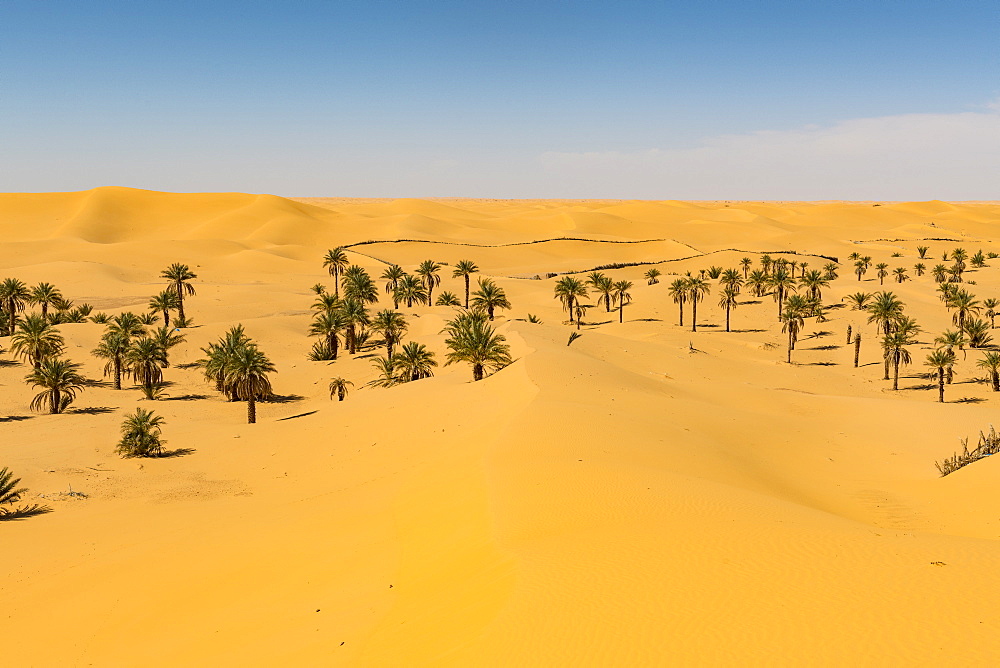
[{"left": 196, "top": 325, "right": 277, "bottom": 424}]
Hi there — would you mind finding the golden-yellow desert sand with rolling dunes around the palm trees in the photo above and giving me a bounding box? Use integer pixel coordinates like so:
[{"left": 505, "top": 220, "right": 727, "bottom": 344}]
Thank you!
[{"left": 0, "top": 188, "right": 1000, "bottom": 666}]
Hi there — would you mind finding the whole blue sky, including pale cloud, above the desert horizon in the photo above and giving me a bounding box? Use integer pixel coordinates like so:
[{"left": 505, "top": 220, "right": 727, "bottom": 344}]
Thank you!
[{"left": 0, "top": 0, "right": 1000, "bottom": 199}]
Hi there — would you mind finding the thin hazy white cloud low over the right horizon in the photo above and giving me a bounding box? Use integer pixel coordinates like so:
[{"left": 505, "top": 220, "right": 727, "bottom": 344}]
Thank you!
[{"left": 539, "top": 100, "right": 1000, "bottom": 200}]
